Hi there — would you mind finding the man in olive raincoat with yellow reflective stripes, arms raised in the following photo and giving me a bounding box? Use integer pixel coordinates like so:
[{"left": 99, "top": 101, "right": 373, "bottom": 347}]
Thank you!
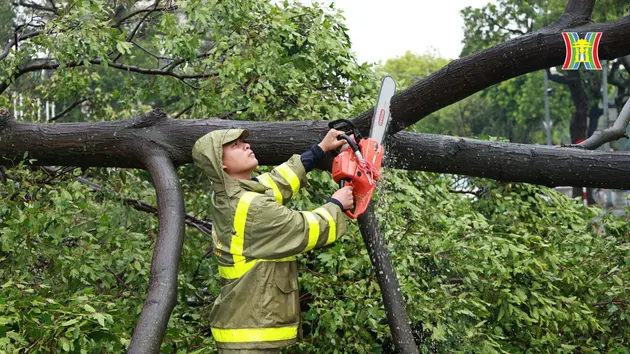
[{"left": 192, "top": 129, "right": 353, "bottom": 353}]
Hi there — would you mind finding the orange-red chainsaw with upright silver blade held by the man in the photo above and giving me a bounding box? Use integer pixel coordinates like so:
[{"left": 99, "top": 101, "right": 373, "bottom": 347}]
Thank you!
[{"left": 328, "top": 76, "right": 396, "bottom": 219}]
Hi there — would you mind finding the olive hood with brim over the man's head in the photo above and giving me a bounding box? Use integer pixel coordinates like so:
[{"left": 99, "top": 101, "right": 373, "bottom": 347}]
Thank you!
[{"left": 192, "top": 129, "right": 249, "bottom": 193}]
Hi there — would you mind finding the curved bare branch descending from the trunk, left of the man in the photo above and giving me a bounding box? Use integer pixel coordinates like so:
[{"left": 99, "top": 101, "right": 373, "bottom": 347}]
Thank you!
[{"left": 128, "top": 149, "right": 185, "bottom": 354}]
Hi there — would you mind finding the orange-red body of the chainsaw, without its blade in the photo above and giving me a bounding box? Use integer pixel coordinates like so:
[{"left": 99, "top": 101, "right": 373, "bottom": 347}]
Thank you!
[{"left": 332, "top": 138, "right": 384, "bottom": 219}]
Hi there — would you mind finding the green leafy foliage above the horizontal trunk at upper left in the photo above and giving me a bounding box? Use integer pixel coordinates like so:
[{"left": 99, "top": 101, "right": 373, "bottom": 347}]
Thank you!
[{"left": 0, "top": 0, "right": 377, "bottom": 121}]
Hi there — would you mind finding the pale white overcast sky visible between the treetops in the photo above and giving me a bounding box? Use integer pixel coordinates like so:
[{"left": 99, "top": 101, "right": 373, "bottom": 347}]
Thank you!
[{"left": 300, "top": 0, "right": 494, "bottom": 63}]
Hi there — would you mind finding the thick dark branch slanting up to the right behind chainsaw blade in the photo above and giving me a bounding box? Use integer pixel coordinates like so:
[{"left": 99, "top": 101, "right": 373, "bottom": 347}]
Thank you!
[{"left": 355, "top": 12, "right": 630, "bottom": 135}]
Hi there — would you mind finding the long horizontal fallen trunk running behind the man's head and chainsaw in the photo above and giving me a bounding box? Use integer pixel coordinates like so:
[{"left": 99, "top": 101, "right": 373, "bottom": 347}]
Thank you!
[{"left": 0, "top": 110, "right": 630, "bottom": 189}]
